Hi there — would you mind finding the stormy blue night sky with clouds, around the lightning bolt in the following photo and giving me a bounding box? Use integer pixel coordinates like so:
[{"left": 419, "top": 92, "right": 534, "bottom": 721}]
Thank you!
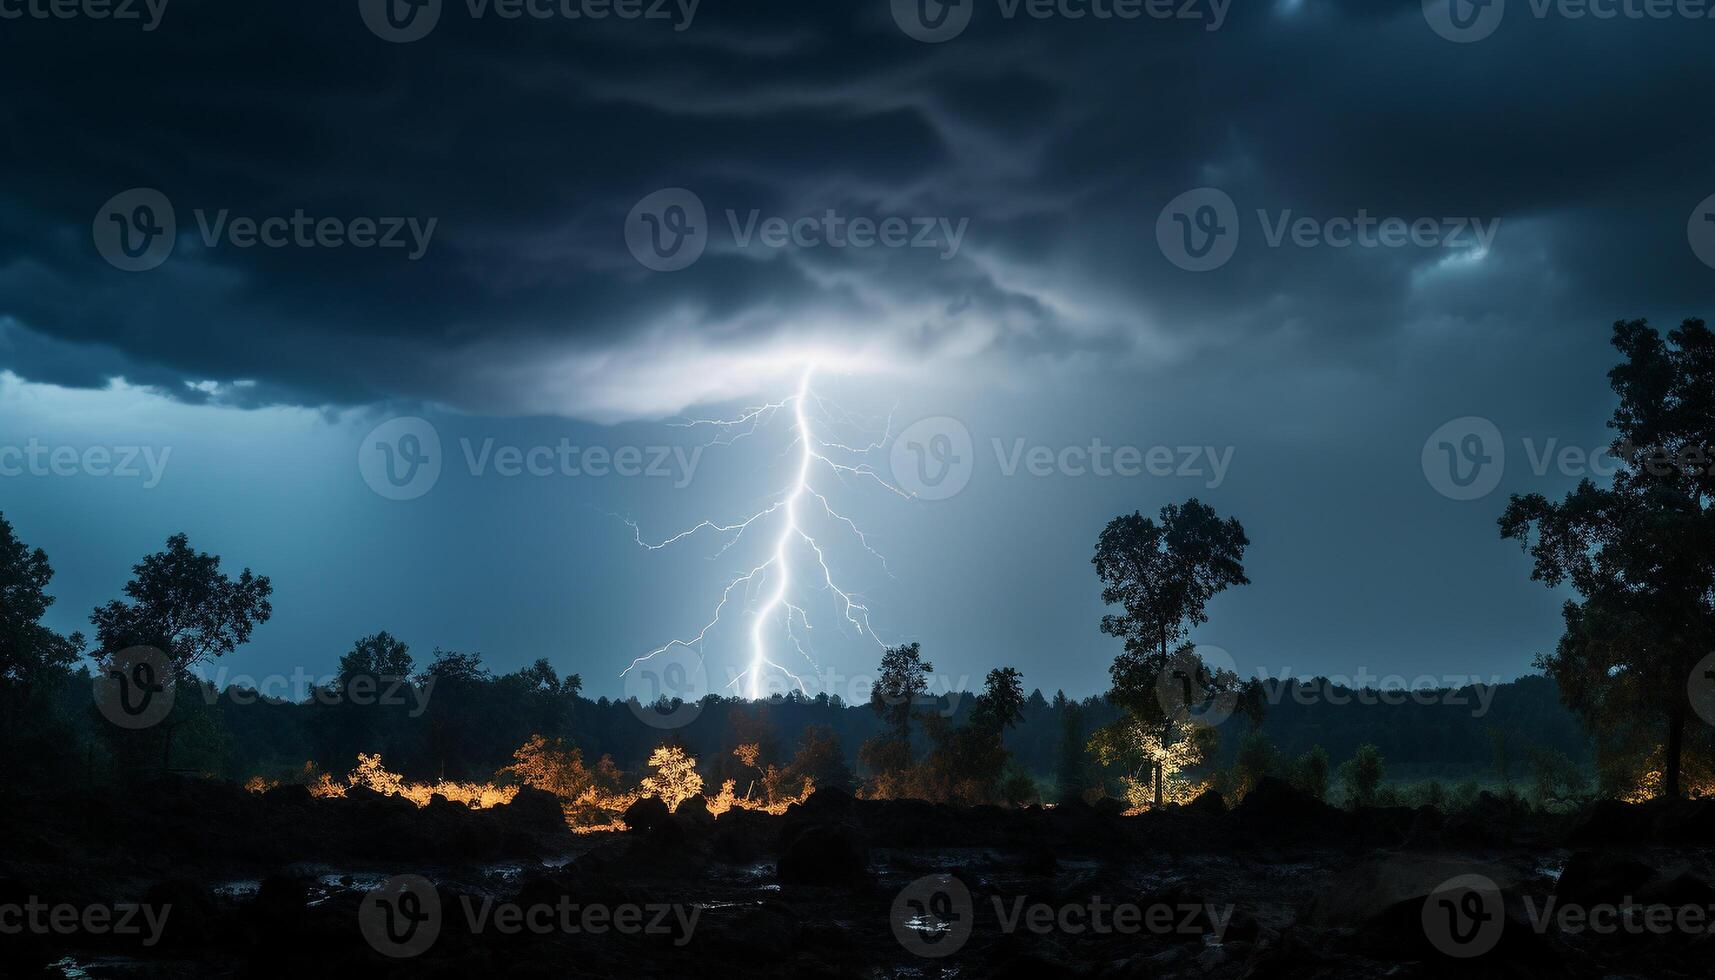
[{"left": 0, "top": 0, "right": 1715, "bottom": 697}]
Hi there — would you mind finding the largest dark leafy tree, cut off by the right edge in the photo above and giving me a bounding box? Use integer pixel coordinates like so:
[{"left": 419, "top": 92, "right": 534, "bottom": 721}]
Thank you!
[{"left": 1499, "top": 319, "right": 1715, "bottom": 796}]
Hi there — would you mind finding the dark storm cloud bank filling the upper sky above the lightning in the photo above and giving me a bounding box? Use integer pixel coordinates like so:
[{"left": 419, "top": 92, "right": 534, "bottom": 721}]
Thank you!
[{"left": 0, "top": 0, "right": 1715, "bottom": 417}]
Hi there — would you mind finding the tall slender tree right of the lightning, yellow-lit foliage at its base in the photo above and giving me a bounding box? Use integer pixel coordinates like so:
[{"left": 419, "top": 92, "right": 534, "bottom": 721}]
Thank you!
[{"left": 1091, "top": 498, "right": 1257, "bottom": 805}]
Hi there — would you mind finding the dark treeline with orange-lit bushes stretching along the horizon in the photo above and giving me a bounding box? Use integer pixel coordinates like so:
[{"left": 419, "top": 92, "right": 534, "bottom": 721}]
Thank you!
[{"left": 0, "top": 518, "right": 1592, "bottom": 805}]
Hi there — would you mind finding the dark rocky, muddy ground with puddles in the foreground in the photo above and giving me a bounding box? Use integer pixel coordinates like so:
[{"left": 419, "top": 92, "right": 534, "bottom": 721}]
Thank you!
[{"left": 0, "top": 779, "right": 1715, "bottom": 978}]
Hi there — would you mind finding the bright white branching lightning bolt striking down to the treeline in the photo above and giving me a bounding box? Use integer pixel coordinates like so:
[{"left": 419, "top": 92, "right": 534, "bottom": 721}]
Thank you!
[{"left": 619, "top": 362, "right": 912, "bottom": 700}]
